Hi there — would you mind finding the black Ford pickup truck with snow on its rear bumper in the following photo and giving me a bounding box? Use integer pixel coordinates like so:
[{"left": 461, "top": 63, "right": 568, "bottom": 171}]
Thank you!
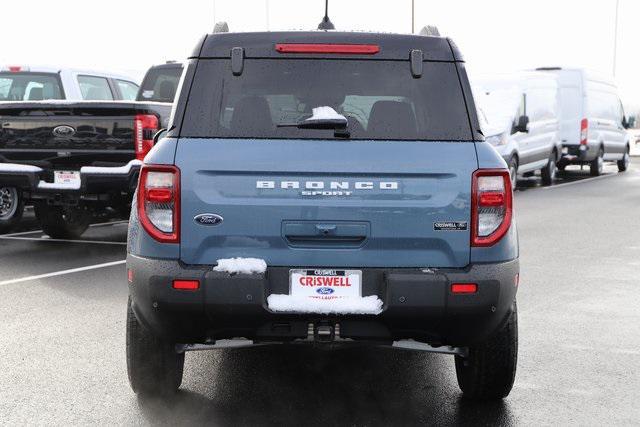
[{"left": 0, "top": 101, "right": 171, "bottom": 239}]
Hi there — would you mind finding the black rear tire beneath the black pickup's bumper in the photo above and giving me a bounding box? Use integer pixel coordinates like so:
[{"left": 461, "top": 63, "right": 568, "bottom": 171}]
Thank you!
[{"left": 33, "top": 202, "right": 92, "bottom": 239}]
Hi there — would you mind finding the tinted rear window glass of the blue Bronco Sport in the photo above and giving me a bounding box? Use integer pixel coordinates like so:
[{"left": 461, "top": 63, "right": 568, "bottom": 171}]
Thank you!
[{"left": 180, "top": 59, "right": 471, "bottom": 141}]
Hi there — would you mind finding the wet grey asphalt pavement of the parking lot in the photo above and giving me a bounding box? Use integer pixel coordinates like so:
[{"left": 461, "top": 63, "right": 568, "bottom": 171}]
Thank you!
[{"left": 0, "top": 163, "right": 640, "bottom": 425}]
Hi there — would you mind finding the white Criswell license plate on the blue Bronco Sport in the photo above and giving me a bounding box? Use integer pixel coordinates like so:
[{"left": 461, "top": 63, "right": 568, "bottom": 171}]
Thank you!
[{"left": 289, "top": 269, "right": 362, "bottom": 299}]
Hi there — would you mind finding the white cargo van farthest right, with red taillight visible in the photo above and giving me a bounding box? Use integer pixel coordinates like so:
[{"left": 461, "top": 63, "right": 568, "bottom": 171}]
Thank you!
[{"left": 537, "top": 67, "right": 630, "bottom": 176}]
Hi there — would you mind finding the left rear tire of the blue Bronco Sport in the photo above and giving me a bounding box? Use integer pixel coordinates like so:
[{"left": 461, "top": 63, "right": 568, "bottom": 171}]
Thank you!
[{"left": 127, "top": 298, "right": 184, "bottom": 396}]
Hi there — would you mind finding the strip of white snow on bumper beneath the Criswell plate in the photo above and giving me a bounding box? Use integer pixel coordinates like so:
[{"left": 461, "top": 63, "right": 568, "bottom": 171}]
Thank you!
[{"left": 267, "top": 294, "right": 382, "bottom": 314}]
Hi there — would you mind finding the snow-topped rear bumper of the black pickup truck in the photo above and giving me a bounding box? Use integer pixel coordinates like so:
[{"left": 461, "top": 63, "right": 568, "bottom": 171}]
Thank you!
[{"left": 0, "top": 160, "right": 142, "bottom": 196}]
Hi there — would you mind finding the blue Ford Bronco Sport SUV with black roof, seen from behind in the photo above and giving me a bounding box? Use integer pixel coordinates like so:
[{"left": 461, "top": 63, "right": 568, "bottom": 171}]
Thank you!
[{"left": 127, "top": 31, "right": 519, "bottom": 399}]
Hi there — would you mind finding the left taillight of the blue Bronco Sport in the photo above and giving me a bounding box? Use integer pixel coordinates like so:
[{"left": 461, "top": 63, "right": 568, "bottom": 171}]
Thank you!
[{"left": 137, "top": 165, "right": 180, "bottom": 243}]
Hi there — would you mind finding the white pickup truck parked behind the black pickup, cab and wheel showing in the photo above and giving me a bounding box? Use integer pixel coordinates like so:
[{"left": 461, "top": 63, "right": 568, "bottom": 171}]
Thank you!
[{"left": 0, "top": 65, "right": 139, "bottom": 233}]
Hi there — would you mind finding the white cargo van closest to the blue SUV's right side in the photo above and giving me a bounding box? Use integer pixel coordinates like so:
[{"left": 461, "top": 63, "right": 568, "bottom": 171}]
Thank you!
[{"left": 472, "top": 71, "right": 562, "bottom": 187}]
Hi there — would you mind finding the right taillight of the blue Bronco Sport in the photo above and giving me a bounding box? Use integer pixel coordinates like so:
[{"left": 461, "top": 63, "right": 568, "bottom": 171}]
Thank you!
[{"left": 471, "top": 169, "right": 513, "bottom": 246}]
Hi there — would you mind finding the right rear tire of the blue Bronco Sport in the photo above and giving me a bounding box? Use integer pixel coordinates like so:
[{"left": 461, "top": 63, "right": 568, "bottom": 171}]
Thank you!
[{"left": 456, "top": 302, "right": 518, "bottom": 400}]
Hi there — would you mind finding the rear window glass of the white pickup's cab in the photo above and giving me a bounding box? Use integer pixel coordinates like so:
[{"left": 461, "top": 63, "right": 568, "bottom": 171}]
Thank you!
[{"left": 0, "top": 73, "right": 64, "bottom": 101}]
